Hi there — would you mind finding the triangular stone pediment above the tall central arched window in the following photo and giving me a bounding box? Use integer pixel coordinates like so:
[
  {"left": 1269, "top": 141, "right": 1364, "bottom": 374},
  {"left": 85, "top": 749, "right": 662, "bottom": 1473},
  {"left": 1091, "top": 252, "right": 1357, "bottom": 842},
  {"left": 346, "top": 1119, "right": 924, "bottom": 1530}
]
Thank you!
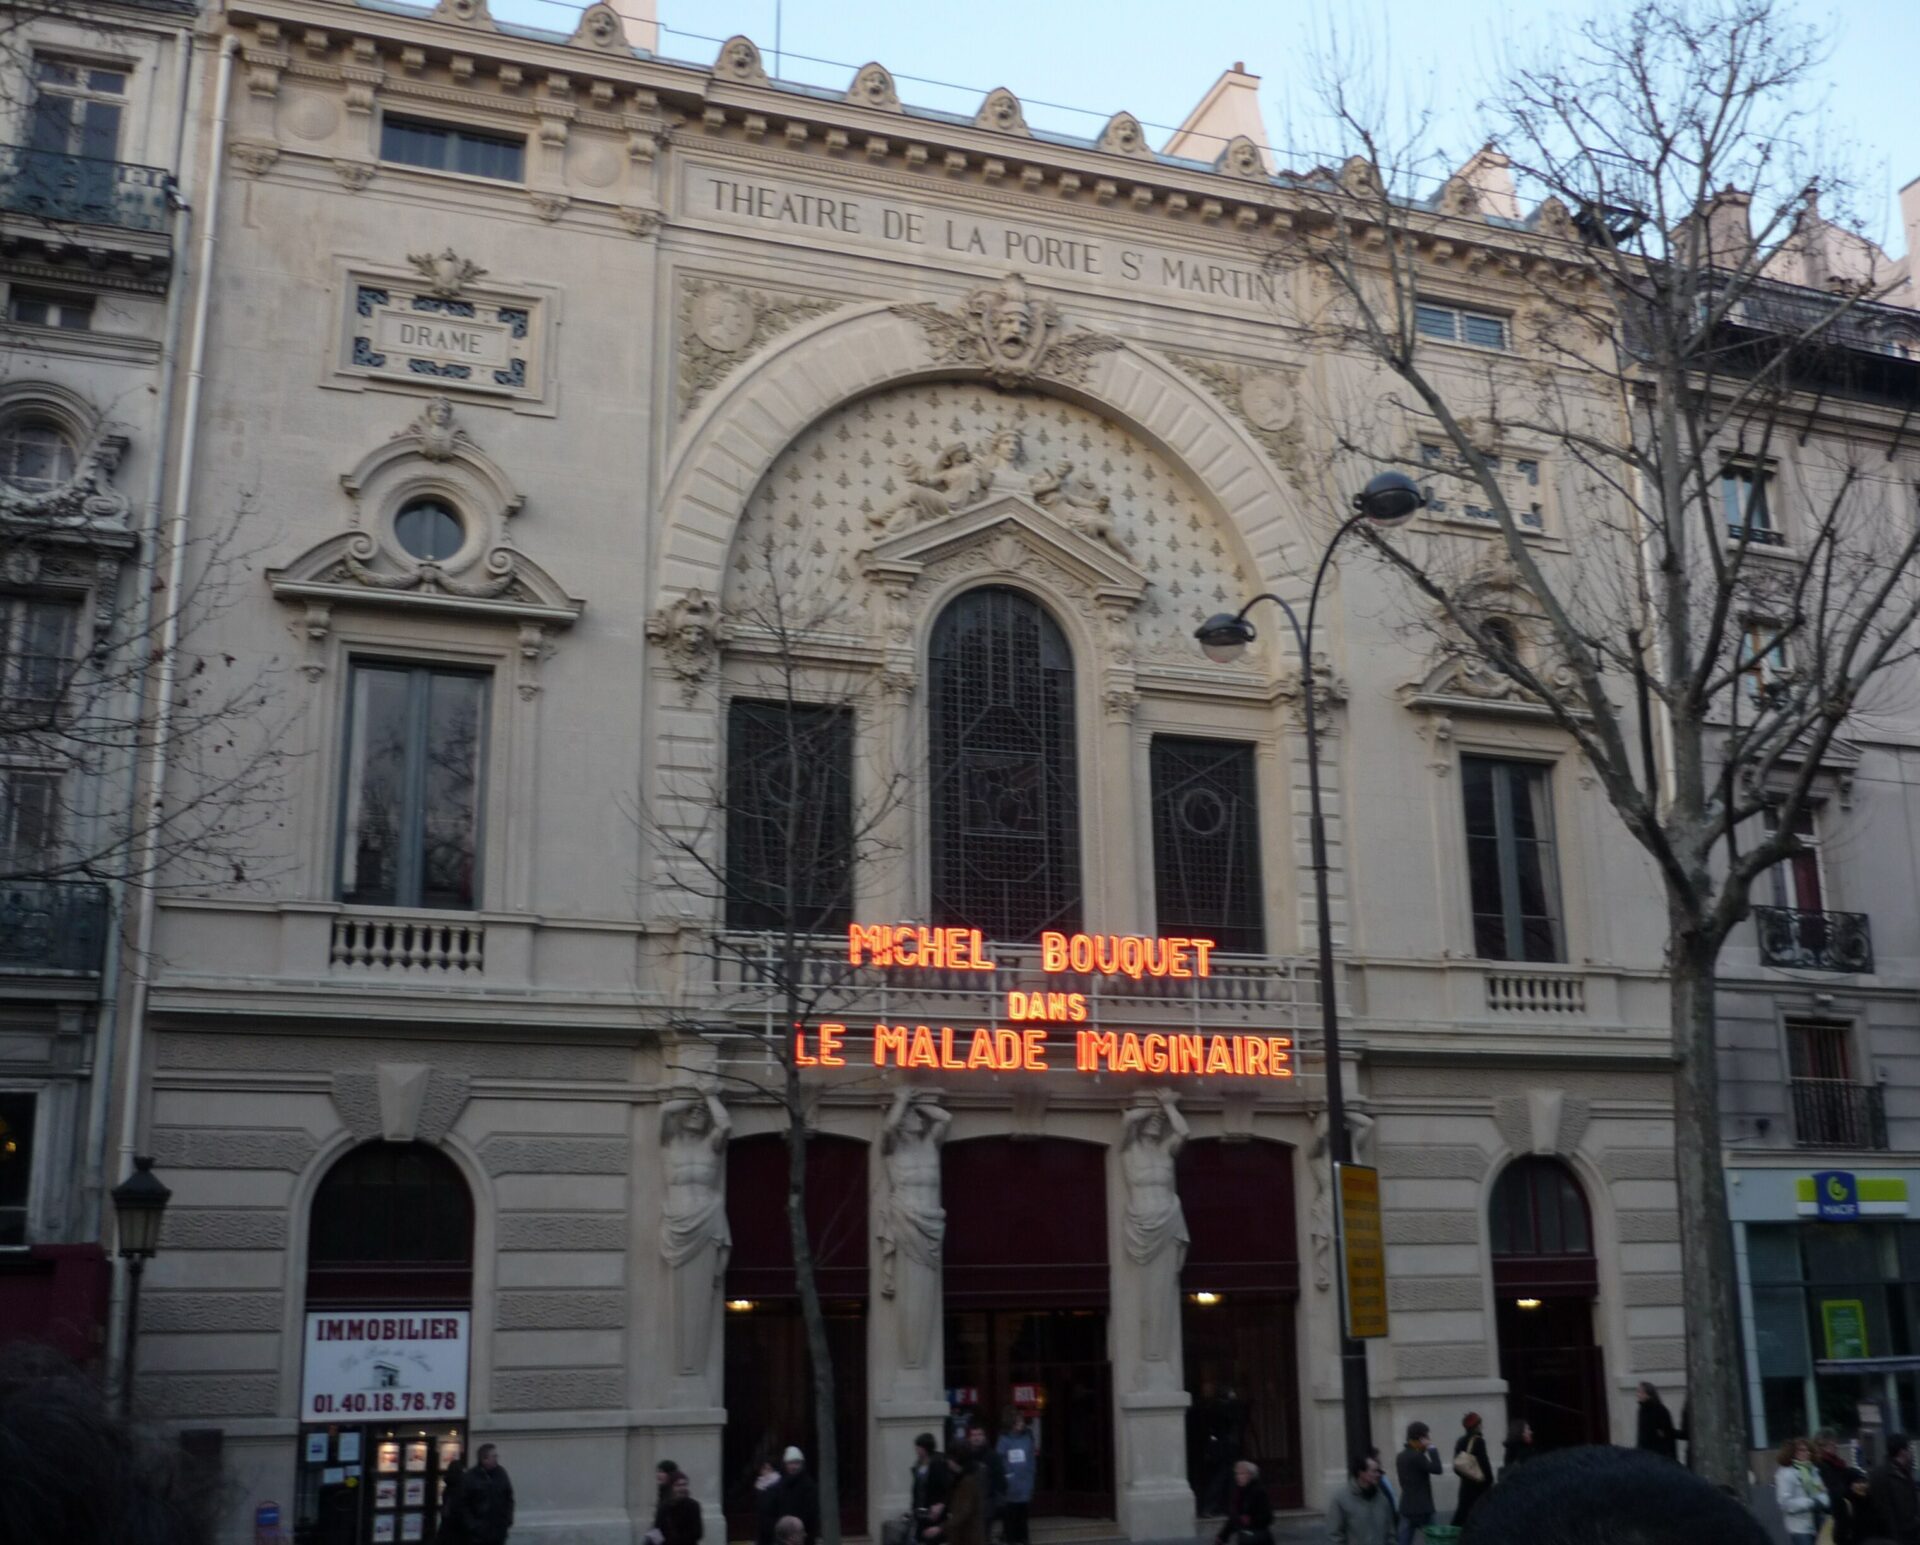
[{"left": 862, "top": 491, "right": 1148, "bottom": 608}]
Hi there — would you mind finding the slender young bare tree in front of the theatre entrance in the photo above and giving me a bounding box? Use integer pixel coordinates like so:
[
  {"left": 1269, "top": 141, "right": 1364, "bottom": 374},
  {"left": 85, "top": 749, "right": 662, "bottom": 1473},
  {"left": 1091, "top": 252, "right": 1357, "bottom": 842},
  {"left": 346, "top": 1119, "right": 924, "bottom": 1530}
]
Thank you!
[{"left": 647, "top": 539, "right": 908, "bottom": 1545}]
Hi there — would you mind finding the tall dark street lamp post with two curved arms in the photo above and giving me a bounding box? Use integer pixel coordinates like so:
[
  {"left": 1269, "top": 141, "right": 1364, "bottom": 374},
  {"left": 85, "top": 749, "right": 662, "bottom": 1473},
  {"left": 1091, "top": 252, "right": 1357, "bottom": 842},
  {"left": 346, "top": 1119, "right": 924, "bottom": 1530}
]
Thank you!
[{"left": 1194, "top": 472, "right": 1427, "bottom": 1457}]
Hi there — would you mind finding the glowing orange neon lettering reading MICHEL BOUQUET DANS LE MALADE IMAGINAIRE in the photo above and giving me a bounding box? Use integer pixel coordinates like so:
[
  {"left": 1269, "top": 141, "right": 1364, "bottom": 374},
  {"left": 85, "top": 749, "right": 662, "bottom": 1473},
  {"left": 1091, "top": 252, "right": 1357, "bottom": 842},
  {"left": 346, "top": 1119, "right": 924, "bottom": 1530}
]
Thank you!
[{"left": 793, "top": 923, "right": 1294, "bottom": 1079}]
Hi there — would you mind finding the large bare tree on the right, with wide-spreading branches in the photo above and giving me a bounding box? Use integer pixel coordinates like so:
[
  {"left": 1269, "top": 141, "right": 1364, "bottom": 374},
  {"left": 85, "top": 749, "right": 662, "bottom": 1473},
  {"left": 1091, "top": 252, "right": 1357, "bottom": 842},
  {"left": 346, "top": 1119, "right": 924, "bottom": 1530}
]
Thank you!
[{"left": 1271, "top": 0, "right": 1920, "bottom": 1486}]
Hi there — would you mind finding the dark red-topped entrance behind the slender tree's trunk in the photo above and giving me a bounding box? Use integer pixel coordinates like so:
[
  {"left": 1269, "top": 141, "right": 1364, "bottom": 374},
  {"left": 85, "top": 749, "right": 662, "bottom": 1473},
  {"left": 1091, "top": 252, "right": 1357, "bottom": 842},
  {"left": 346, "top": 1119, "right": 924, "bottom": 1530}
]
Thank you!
[{"left": 720, "top": 1132, "right": 868, "bottom": 1539}]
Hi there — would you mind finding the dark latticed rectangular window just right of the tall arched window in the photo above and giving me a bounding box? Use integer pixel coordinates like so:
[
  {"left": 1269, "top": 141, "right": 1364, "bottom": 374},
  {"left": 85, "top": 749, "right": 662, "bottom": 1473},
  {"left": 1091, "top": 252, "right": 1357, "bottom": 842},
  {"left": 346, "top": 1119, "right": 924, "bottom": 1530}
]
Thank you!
[{"left": 1152, "top": 735, "right": 1267, "bottom": 956}]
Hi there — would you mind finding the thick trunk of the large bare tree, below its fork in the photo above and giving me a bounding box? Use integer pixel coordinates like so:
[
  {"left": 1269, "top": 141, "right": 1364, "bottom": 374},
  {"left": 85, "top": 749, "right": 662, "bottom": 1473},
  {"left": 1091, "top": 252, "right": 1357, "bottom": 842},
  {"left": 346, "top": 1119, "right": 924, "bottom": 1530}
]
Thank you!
[{"left": 1670, "top": 915, "right": 1747, "bottom": 1501}]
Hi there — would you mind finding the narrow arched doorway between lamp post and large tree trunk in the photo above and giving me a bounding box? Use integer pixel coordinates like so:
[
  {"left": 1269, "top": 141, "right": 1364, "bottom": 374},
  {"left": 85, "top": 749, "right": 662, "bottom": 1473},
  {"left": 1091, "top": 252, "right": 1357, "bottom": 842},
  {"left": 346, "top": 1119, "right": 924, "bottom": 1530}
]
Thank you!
[{"left": 1488, "top": 1155, "right": 1611, "bottom": 1449}]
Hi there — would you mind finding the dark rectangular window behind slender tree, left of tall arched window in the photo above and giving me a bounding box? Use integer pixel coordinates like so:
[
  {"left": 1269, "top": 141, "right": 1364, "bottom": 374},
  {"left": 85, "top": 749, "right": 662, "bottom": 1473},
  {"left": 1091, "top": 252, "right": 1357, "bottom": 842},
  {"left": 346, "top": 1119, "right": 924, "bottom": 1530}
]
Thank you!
[{"left": 726, "top": 701, "right": 852, "bottom": 933}]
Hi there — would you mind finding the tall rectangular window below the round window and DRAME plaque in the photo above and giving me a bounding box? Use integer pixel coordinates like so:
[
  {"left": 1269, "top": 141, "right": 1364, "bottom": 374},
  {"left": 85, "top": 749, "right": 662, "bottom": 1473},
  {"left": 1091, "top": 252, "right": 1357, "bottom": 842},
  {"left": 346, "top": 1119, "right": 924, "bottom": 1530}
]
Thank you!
[{"left": 340, "top": 664, "right": 490, "bottom": 910}]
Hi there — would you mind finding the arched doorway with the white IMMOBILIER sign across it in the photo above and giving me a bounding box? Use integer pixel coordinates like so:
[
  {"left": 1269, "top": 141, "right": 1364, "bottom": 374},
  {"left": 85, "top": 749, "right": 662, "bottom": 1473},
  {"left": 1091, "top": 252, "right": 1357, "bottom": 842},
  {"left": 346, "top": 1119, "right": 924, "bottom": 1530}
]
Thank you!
[{"left": 294, "top": 1142, "right": 474, "bottom": 1545}]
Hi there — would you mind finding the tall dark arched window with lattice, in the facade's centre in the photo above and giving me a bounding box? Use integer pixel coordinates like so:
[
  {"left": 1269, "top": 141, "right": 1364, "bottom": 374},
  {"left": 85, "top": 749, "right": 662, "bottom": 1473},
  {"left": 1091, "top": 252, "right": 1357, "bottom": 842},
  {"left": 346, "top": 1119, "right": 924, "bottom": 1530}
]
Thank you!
[{"left": 929, "top": 587, "right": 1081, "bottom": 940}]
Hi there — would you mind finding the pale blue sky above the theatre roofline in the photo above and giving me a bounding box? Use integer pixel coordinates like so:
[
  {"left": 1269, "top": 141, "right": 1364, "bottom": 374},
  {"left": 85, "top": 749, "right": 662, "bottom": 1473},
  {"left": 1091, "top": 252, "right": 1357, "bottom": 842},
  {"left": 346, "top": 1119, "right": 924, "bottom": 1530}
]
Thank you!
[{"left": 493, "top": 0, "right": 1920, "bottom": 255}]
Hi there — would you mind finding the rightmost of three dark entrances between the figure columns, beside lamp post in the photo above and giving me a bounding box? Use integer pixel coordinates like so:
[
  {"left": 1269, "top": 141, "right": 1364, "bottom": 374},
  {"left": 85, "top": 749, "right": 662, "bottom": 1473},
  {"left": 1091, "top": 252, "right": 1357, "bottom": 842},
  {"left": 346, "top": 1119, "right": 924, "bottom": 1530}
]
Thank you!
[{"left": 1179, "top": 1138, "right": 1304, "bottom": 1516}]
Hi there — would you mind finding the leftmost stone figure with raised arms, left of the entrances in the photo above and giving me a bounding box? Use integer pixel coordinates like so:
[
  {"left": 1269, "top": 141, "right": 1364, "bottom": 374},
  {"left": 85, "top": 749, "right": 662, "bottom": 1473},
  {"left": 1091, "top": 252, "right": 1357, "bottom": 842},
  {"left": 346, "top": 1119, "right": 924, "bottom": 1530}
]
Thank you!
[{"left": 660, "top": 1088, "right": 733, "bottom": 1374}]
